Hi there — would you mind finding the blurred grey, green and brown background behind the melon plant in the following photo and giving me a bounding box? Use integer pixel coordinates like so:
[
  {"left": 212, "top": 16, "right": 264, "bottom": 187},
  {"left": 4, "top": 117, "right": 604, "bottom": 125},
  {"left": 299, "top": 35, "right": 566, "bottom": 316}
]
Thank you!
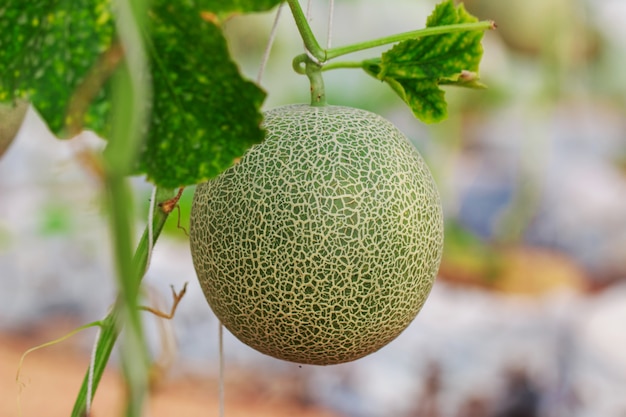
[{"left": 0, "top": 0, "right": 626, "bottom": 417}]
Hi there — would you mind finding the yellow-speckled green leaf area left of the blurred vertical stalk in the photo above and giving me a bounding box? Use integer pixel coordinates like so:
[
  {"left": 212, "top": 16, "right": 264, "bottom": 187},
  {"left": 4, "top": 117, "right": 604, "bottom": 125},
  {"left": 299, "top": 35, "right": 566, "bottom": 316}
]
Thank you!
[{"left": 0, "top": 0, "right": 115, "bottom": 135}]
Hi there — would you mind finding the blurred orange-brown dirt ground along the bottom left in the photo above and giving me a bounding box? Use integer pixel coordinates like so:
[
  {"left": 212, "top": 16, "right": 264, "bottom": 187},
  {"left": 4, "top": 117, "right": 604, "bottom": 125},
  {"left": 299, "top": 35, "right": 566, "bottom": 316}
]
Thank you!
[{"left": 0, "top": 326, "right": 339, "bottom": 417}]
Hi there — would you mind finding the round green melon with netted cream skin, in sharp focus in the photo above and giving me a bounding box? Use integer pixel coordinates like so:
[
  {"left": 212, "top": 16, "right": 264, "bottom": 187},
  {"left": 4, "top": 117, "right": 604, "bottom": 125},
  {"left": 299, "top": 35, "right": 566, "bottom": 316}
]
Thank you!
[{"left": 190, "top": 105, "right": 443, "bottom": 365}]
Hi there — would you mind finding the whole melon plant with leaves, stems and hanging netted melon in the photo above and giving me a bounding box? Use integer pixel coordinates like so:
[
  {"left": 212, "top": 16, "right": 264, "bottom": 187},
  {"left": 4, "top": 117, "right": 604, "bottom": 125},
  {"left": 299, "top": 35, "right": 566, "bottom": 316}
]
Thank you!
[{"left": 0, "top": 0, "right": 494, "bottom": 417}]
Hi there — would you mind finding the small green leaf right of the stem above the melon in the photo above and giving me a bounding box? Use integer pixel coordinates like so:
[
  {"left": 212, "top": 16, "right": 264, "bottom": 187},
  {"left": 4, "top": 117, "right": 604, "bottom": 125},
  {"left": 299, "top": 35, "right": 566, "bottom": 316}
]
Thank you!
[{"left": 363, "top": 0, "right": 484, "bottom": 123}]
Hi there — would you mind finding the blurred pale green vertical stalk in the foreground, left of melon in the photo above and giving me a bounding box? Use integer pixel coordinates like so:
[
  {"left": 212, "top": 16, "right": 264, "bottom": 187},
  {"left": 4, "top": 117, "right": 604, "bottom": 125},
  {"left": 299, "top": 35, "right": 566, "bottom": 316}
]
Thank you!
[{"left": 104, "top": 0, "right": 151, "bottom": 417}]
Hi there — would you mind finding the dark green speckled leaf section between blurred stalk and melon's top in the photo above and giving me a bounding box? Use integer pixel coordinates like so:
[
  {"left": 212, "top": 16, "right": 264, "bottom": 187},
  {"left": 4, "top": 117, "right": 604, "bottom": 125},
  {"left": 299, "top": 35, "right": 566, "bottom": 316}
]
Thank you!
[{"left": 139, "top": 1, "right": 265, "bottom": 188}]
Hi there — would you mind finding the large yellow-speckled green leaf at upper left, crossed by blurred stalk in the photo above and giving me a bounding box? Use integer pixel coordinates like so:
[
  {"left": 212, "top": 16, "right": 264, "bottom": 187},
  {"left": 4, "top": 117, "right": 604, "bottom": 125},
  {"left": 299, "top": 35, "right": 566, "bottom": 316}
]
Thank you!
[{"left": 0, "top": 0, "right": 280, "bottom": 188}]
